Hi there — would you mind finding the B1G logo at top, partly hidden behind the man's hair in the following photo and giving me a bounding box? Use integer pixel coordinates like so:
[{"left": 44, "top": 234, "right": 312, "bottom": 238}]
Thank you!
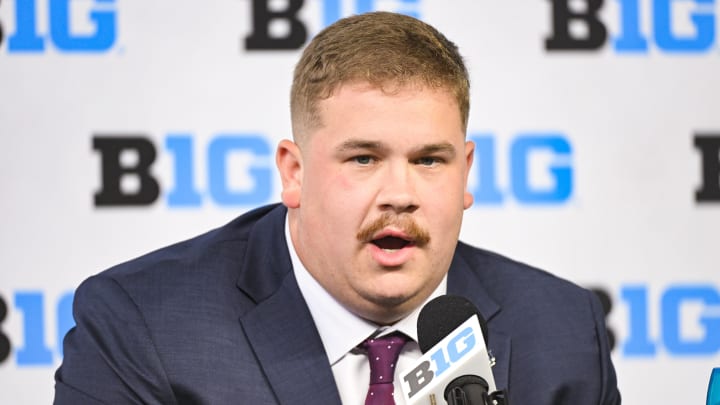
[{"left": 245, "top": 0, "right": 420, "bottom": 50}]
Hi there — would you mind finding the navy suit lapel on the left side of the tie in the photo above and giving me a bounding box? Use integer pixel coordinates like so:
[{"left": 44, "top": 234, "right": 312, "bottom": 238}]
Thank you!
[{"left": 233, "top": 208, "right": 340, "bottom": 404}]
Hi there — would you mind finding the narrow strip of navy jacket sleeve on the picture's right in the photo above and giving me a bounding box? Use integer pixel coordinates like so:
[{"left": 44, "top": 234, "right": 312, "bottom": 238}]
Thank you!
[{"left": 588, "top": 292, "right": 621, "bottom": 405}]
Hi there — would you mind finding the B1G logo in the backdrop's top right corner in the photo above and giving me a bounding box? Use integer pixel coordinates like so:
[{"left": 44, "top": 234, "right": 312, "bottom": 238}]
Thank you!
[{"left": 545, "top": 0, "right": 717, "bottom": 53}]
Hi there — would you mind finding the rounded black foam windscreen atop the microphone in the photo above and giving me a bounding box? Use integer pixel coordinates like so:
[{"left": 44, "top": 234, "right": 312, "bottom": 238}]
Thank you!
[{"left": 418, "top": 295, "right": 488, "bottom": 354}]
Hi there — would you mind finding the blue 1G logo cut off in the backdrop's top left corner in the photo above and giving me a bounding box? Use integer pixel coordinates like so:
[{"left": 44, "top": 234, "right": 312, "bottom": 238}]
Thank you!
[{"left": 0, "top": 0, "right": 117, "bottom": 53}]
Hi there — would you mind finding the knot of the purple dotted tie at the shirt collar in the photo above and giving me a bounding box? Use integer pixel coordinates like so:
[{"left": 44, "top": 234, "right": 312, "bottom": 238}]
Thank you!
[{"left": 362, "top": 332, "right": 408, "bottom": 384}]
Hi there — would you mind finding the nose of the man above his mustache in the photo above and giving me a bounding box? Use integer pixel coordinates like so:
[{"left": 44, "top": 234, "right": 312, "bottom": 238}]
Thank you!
[{"left": 378, "top": 162, "right": 419, "bottom": 214}]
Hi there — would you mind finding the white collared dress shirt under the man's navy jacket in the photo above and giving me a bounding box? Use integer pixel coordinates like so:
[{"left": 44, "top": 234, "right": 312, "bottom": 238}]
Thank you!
[{"left": 285, "top": 213, "right": 447, "bottom": 405}]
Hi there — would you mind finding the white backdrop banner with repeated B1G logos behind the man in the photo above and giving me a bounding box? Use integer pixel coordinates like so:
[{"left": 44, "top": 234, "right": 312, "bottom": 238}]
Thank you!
[{"left": 0, "top": 0, "right": 720, "bottom": 404}]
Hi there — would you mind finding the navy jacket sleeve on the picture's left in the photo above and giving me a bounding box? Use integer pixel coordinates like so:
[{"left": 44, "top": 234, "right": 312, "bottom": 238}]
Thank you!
[{"left": 54, "top": 275, "right": 176, "bottom": 405}]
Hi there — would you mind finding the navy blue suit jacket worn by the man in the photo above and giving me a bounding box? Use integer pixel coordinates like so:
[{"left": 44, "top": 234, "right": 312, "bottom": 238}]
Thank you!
[{"left": 55, "top": 205, "right": 620, "bottom": 405}]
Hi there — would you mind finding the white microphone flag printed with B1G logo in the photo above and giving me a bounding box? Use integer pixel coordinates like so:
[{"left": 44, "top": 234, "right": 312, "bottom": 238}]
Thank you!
[{"left": 400, "top": 316, "right": 495, "bottom": 404}]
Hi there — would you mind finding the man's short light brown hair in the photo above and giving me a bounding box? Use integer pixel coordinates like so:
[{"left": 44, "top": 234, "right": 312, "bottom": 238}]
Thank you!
[{"left": 290, "top": 12, "right": 470, "bottom": 143}]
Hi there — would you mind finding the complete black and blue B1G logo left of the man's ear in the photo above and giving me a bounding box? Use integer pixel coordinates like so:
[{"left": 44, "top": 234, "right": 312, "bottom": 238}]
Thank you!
[{"left": 92, "top": 133, "right": 273, "bottom": 208}]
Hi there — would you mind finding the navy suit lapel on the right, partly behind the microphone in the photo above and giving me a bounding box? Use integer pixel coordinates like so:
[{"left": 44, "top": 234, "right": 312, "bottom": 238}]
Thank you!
[{"left": 448, "top": 250, "right": 510, "bottom": 389}]
